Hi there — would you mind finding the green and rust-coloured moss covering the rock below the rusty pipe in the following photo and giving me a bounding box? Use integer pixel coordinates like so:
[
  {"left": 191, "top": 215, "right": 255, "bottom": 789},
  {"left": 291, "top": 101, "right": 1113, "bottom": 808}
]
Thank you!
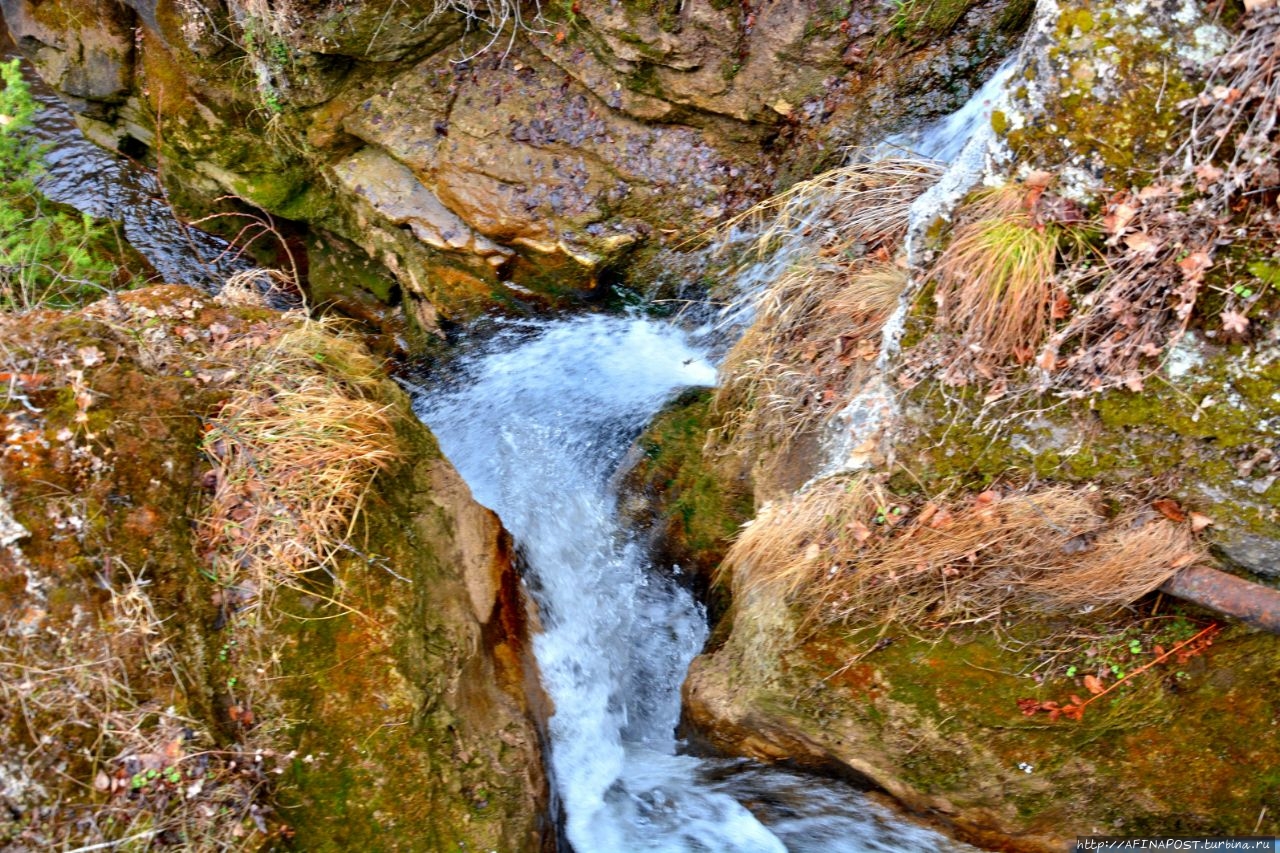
[{"left": 718, "top": 604, "right": 1280, "bottom": 839}]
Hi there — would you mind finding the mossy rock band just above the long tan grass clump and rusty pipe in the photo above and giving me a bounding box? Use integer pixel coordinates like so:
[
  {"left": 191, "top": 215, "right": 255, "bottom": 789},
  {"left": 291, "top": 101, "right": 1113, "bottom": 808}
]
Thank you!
[{"left": 897, "top": 323, "right": 1280, "bottom": 575}]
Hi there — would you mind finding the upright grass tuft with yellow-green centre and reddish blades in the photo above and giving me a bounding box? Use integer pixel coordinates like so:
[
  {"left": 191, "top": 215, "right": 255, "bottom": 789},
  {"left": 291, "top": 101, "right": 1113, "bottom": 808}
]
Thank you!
[{"left": 929, "top": 184, "right": 1085, "bottom": 379}]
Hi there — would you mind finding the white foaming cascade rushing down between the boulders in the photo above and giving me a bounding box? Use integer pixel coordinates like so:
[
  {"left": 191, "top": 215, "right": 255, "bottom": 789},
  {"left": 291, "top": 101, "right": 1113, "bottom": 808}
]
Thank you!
[{"left": 416, "top": 316, "right": 962, "bottom": 853}]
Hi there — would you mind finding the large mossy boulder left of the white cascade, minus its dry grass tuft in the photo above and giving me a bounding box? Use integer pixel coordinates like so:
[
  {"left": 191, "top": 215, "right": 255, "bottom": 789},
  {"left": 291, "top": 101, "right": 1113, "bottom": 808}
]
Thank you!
[{"left": 0, "top": 287, "right": 550, "bottom": 850}]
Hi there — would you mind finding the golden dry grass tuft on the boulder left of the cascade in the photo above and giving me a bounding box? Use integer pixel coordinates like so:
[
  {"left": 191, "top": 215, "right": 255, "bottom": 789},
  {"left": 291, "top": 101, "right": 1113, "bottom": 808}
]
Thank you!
[{"left": 202, "top": 315, "right": 393, "bottom": 592}]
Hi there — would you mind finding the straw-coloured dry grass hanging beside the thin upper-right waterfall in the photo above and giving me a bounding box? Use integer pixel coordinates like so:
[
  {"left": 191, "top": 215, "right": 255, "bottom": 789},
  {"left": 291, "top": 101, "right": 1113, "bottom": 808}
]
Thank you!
[{"left": 716, "top": 159, "right": 942, "bottom": 456}]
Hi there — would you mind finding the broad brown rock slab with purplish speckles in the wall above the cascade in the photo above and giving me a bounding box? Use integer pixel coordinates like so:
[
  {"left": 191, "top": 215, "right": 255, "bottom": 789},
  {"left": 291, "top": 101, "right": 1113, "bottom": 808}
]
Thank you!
[{"left": 343, "top": 39, "right": 749, "bottom": 268}]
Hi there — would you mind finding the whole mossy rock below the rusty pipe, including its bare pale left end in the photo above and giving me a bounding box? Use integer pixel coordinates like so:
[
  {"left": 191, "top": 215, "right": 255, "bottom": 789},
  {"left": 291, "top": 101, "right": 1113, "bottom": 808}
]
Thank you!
[{"left": 685, "top": 601, "right": 1280, "bottom": 850}]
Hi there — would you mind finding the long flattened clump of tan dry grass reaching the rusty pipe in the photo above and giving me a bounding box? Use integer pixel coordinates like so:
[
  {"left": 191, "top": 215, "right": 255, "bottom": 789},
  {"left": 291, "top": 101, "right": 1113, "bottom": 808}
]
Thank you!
[{"left": 724, "top": 476, "right": 1203, "bottom": 625}]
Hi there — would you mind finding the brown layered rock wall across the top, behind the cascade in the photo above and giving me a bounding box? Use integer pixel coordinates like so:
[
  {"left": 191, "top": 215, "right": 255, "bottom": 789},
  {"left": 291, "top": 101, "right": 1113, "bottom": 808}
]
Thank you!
[{"left": 3, "top": 0, "right": 1027, "bottom": 332}]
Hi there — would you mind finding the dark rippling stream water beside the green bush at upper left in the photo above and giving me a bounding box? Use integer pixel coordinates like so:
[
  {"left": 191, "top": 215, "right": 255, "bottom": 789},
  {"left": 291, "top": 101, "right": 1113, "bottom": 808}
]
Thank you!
[{"left": 0, "top": 39, "right": 252, "bottom": 289}]
